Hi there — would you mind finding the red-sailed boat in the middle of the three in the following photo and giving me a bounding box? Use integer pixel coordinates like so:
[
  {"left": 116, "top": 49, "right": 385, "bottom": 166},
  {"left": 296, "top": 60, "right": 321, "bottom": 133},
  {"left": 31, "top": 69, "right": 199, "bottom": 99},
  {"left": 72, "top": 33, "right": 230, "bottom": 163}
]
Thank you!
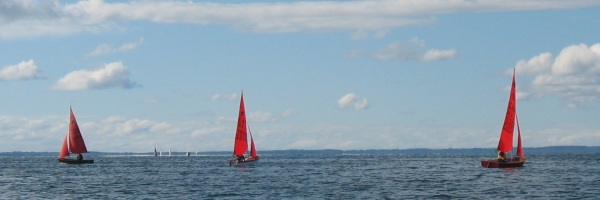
[{"left": 229, "top": 93, "right": 260, "bottom": 165}]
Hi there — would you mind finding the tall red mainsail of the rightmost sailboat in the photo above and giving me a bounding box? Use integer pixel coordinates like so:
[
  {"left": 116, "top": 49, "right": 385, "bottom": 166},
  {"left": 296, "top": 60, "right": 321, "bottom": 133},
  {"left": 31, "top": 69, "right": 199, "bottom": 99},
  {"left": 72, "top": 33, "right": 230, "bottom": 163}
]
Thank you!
[{"left": 498, "top": 72, "right": 517, "bottom": 152}]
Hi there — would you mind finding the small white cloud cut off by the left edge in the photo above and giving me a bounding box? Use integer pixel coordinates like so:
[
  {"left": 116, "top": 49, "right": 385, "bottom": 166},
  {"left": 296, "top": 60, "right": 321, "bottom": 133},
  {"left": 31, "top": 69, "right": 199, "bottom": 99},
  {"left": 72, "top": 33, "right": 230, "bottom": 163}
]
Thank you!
[{"left": 0, "top": 60, "right": 42, "bottom": 80}]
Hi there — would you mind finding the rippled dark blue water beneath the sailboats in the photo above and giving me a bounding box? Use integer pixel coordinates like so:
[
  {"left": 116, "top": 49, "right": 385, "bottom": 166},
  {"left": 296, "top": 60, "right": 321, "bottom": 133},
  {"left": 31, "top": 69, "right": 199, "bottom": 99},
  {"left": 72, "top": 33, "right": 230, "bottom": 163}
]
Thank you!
[{"left": 0, "top": 154, "right": 600, "bottom": 199}]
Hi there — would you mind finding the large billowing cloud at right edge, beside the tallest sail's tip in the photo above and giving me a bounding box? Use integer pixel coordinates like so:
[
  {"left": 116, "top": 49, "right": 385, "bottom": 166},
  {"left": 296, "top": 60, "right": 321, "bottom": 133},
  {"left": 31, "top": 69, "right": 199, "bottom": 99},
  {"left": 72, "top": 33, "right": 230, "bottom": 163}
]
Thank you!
[{"left": 511, "top": 43, "right": 600, "bottom": 107}]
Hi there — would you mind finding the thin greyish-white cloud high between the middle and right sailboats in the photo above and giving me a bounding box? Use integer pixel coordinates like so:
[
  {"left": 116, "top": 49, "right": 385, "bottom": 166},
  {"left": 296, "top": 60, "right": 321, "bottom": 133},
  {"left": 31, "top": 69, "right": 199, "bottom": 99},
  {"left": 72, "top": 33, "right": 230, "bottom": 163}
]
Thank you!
[{"left": 372, "top": 38, "right": 458, "bottom": 61}]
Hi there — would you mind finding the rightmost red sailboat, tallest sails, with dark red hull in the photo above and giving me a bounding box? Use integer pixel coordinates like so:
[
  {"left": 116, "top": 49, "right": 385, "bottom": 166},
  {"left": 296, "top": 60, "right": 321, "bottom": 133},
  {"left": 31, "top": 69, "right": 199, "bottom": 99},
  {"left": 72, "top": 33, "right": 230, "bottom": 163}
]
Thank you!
[{"left": 481, "top": 70, "right": 527, "bottom": 168}]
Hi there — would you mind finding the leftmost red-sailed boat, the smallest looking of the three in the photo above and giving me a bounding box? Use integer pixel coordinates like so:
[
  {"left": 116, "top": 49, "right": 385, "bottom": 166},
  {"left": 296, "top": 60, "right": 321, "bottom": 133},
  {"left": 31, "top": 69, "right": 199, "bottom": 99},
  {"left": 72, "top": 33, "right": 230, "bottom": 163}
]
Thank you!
[{"left": 58, "top": 108, "right": 94, "bottom": 164}]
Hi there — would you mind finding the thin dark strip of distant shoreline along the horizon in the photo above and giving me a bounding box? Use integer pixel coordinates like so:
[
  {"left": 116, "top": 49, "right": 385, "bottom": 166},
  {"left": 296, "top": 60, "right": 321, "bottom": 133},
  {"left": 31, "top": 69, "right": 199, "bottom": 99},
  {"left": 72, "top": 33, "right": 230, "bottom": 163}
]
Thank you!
[{"left": 0, "top": 146, "right": 600, "bottom": 156}]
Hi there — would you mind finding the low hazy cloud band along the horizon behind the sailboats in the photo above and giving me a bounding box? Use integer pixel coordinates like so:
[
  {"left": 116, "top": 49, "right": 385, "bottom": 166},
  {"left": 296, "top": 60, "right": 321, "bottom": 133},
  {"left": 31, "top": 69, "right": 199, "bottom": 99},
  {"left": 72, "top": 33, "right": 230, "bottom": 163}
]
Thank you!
[{"left": 0, "top": 112, "right": 600, "bottom": 152}]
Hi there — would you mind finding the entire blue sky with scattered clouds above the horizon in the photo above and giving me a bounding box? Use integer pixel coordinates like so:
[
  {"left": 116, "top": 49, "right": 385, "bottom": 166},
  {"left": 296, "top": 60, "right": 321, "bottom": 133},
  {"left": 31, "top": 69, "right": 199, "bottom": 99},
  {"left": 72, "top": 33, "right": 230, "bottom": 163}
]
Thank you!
[{"left": 0, "top": 0, "right": 600, "bottom": 154}]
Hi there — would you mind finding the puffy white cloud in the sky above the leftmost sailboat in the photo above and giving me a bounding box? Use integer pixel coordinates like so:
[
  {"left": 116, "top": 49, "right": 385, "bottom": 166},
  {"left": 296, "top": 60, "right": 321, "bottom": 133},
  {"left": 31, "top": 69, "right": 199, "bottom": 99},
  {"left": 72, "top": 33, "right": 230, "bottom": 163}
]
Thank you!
[{"left": 53, "top": 61, "right": 138, "bottom": 90}]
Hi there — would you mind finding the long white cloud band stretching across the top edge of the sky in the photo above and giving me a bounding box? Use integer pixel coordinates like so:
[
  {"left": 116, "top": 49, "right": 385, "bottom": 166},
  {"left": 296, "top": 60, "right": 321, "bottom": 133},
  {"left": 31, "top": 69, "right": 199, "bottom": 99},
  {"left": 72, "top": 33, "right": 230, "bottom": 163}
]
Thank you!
[{"left": 0, "top": 0, "right": 600, "bottom": 38}]
